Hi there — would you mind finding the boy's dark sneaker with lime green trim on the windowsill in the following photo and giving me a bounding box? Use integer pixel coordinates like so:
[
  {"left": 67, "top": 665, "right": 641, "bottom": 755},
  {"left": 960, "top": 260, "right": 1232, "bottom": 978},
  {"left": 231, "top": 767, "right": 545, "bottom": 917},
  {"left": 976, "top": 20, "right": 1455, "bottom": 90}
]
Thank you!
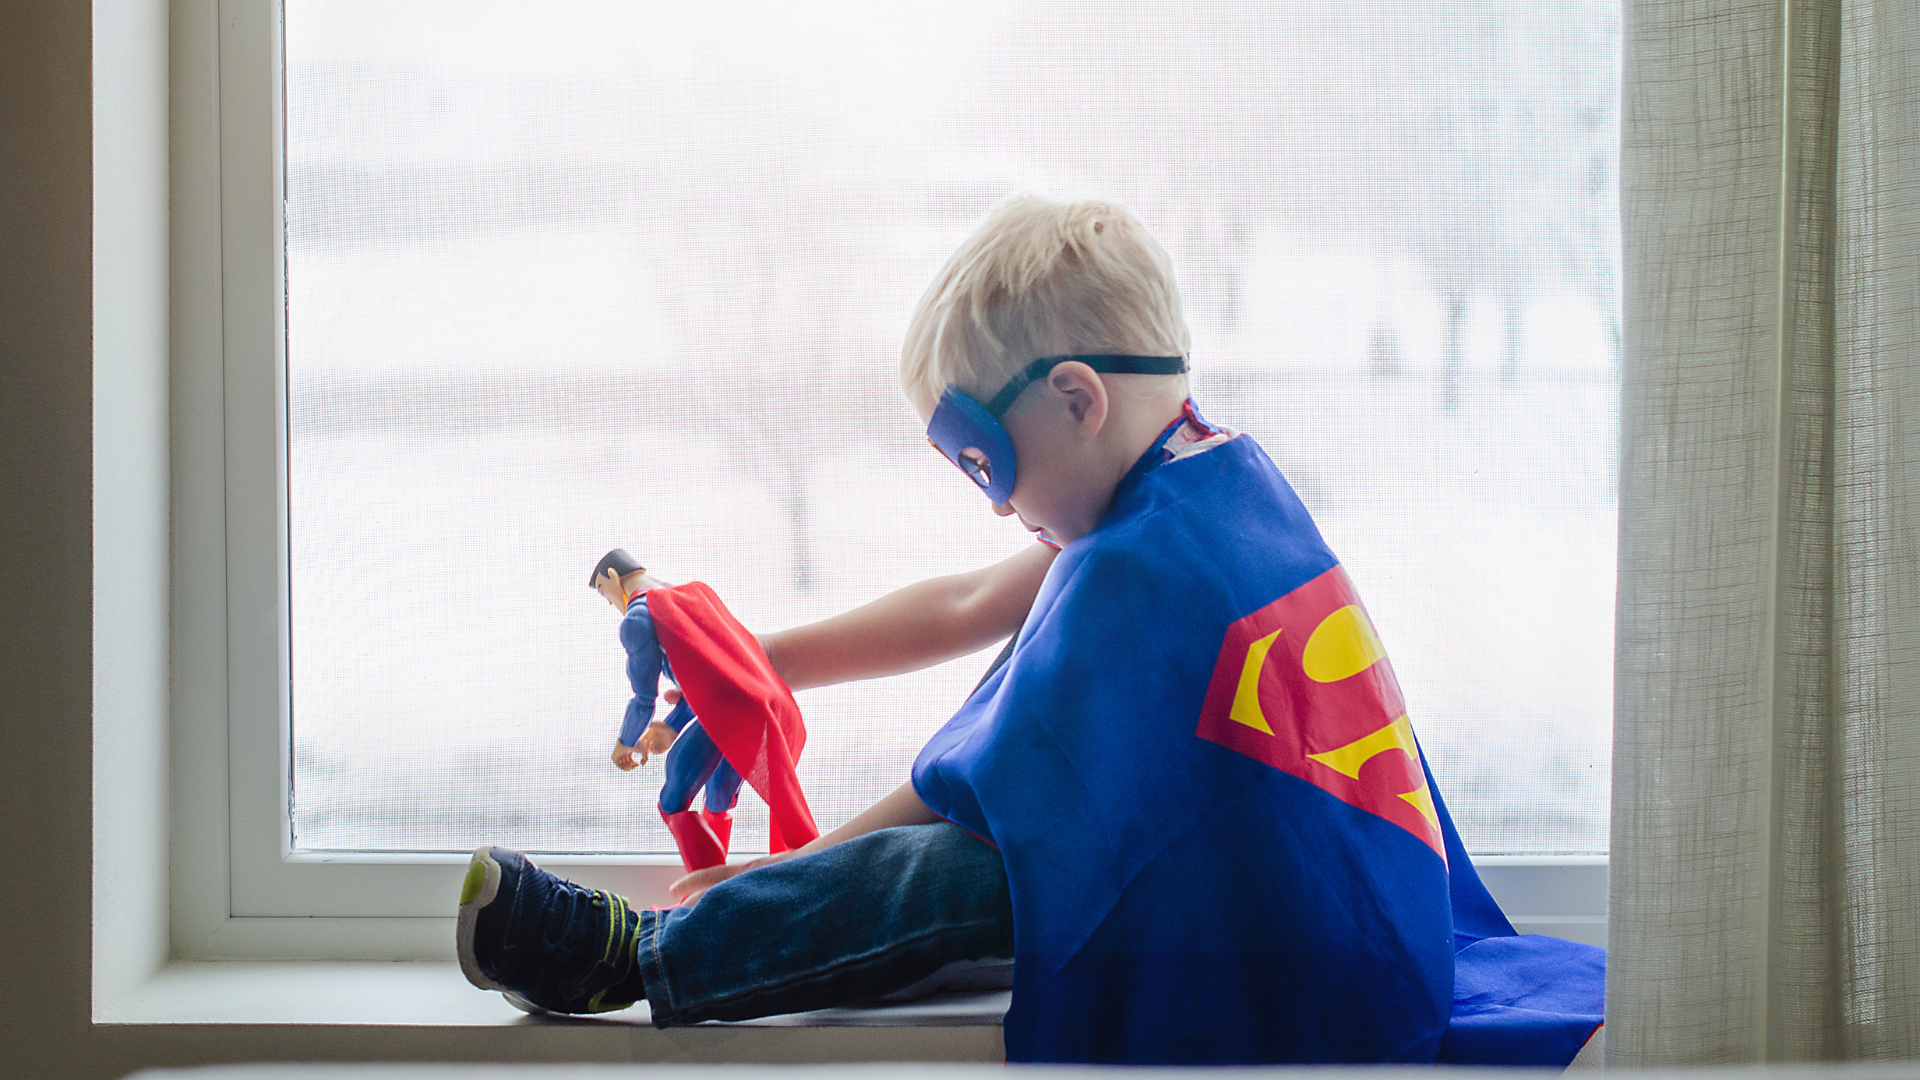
[{"left": 455, "top": 847, "right": 643, "bottom": 1013}]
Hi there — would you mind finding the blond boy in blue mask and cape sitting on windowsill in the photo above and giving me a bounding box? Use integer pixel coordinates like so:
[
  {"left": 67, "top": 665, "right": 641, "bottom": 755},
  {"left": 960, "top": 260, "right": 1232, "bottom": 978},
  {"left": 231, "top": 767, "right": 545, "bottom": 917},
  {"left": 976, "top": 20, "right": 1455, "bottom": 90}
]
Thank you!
[{"left": 459, "top": 198, "right": 1599, "bottom": 1065}]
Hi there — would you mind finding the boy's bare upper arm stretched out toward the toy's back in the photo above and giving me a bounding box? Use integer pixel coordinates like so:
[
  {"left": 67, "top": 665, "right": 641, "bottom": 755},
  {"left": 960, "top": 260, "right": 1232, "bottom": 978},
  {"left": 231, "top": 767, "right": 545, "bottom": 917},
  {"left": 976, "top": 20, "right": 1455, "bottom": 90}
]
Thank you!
[{"left": 760, "top": 544, "right": 1060, "bottom": 687}]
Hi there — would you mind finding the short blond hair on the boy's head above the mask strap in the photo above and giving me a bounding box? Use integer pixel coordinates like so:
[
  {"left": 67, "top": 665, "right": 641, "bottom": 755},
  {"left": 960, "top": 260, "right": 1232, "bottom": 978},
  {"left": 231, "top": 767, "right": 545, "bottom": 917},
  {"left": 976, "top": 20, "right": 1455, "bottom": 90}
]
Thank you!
[{"left": 900, "top": 194, "right": 1188, "bottom": 411}]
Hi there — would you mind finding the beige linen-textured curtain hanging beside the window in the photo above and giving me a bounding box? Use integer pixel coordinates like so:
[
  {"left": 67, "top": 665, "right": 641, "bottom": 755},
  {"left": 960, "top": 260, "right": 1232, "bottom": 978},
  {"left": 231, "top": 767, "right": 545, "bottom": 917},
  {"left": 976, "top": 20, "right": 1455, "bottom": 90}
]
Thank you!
[{"left": 1607, "top": 0, "right": 1920, "bottom": 1067}]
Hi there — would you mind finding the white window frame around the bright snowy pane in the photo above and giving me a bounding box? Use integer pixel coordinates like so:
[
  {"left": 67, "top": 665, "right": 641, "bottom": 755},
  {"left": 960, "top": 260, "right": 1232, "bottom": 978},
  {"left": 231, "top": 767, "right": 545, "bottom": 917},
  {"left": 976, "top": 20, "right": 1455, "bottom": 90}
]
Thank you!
[{"left": 171, "top": 0, "right": 1607, "bottom": 959}]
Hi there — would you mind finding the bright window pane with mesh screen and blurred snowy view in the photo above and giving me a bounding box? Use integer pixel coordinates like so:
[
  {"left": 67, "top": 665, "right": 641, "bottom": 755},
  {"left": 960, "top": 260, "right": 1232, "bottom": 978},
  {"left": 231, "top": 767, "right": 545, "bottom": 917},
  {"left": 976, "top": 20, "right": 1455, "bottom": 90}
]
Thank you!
[{"left": 286, "top": 0, "right": 1619, "bottom": 851}]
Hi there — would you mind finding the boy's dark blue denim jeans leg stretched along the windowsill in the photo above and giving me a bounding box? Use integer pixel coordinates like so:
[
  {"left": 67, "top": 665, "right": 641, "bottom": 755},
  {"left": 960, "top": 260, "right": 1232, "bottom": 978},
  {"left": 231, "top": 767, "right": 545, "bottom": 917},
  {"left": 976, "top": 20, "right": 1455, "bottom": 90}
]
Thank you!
[{"left": 637, "top": 822, "right": 1014, "bottom": 1026}]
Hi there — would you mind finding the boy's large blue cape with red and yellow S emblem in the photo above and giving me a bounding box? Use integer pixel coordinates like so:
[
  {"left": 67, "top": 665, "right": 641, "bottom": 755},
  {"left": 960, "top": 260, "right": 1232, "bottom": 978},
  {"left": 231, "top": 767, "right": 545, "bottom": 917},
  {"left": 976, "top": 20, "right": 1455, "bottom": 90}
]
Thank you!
[{"left": 914, "top": 426, "right": 1603, "bottom": 1065}]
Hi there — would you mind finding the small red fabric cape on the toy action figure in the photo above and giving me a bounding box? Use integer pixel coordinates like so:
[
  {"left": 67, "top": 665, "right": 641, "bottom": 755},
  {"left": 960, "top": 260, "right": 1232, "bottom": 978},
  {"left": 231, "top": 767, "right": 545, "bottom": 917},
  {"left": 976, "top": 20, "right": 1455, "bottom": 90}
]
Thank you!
[{"left": 647, "top": 582, "right": 820, "bottom": 851}]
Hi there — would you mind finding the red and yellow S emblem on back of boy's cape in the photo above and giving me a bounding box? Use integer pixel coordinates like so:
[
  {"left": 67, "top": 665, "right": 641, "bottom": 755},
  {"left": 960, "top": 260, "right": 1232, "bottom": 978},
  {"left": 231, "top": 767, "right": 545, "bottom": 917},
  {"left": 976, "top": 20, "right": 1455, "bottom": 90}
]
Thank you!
[{"left": 1194, "top": 565, "right": 1446, "bottom": 861}]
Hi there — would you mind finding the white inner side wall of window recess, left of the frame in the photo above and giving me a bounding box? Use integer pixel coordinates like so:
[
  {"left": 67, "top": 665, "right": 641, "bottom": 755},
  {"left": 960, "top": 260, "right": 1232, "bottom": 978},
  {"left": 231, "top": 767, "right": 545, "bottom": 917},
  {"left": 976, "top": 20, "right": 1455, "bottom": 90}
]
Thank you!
[{"left": 92, "top": 0, "right": 169, "bottom": 1015}]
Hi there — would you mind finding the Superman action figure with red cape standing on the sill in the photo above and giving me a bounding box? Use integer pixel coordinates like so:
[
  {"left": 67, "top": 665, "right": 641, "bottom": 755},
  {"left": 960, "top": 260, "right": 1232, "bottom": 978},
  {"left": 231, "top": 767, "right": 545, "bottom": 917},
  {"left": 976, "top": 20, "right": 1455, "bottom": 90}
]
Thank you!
[{"left": 589, "top": 548, "right": 818, "bottom": 872}]
